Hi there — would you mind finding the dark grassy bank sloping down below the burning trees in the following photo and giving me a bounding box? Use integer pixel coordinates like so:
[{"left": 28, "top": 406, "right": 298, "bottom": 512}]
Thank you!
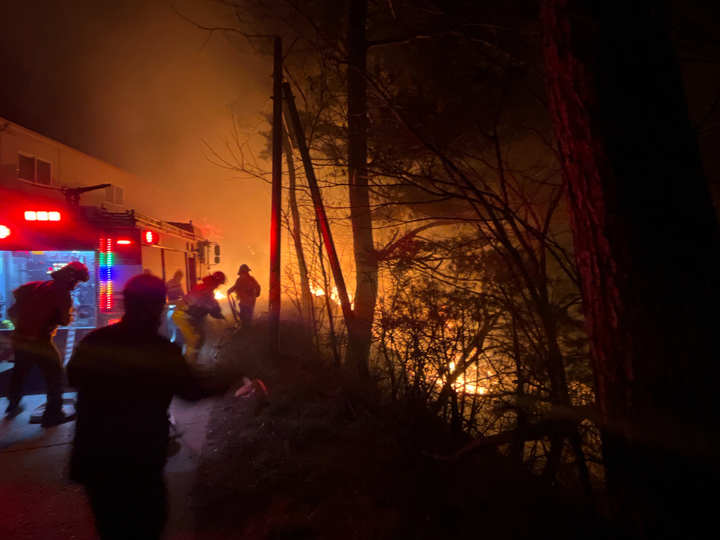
[{"left": 191, "top": 320, "right": 599, "bottom": 540}]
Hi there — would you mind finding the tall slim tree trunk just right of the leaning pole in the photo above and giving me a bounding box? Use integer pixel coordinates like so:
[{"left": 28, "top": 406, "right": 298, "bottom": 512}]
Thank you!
[{"left": 346, "top": 0, "right": 378, "bottom": 379}]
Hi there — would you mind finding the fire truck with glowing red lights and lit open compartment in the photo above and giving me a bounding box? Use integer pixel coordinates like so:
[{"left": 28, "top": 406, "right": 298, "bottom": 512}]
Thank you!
[{"left": 0, "top": 185, "right": 214, "bottom": 361}]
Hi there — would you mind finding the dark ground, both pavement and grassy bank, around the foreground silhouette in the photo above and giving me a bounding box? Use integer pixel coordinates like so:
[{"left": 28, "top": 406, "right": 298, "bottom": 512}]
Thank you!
[{"left": 0, "top": 318, "right": 600, "bottom": 540}]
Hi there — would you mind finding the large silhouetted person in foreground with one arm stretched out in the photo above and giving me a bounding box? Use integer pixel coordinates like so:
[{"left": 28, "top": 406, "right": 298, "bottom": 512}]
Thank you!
[{"left": 67, "top": 274, "right": 230, "bottom": 540}]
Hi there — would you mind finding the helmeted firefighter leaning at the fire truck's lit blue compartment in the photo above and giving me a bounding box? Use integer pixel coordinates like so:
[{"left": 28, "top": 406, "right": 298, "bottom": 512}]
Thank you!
[{"left": 5, "top": 261, "right": 90, "bottom": 428}]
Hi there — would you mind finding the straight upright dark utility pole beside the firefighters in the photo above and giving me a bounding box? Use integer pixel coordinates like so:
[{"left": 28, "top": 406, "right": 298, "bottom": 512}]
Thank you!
[{"left": 268, "top": 37, "right": 283, "bottom": 358}]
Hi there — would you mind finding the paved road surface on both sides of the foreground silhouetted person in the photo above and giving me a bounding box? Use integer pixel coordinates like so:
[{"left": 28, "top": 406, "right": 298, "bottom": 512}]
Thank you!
[{"left": 0, "top": 394, "right": 217, "bottom": 540}]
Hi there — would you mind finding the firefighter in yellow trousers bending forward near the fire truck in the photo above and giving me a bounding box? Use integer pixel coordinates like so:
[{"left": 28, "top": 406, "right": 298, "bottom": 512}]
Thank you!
[{"left": 173, "top": 272, "right": 225, "bottom": 364}]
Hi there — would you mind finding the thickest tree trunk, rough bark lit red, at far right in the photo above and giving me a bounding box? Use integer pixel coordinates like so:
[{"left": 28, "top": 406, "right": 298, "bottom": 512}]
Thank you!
[{"left": 542, "top": 0, "right": 720, "bottom": 538}]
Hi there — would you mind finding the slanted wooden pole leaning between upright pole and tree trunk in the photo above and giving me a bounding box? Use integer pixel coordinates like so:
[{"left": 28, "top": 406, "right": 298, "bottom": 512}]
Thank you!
[{"left": 283, "top": 83, "right": 354, "bottom": 327}]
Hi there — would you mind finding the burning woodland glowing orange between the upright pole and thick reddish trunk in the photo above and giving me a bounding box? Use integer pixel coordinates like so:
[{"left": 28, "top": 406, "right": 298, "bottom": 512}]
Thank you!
[{"left": 216, "top": 0, "right": 602, "bottom": 493}]
